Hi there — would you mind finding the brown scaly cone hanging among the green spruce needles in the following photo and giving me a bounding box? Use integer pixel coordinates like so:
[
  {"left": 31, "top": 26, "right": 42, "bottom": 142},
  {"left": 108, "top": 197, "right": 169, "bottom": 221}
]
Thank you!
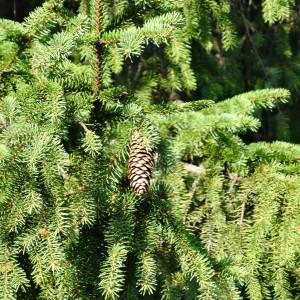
[{"left": 128, "top": 131, "right": 155, "bottom": 196}]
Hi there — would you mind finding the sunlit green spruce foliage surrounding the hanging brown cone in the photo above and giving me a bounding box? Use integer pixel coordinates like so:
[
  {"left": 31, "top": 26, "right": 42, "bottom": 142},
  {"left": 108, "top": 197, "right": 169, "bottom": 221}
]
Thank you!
[{"left": 0, "top": 0, "right": 300, "bottom": 300}]
